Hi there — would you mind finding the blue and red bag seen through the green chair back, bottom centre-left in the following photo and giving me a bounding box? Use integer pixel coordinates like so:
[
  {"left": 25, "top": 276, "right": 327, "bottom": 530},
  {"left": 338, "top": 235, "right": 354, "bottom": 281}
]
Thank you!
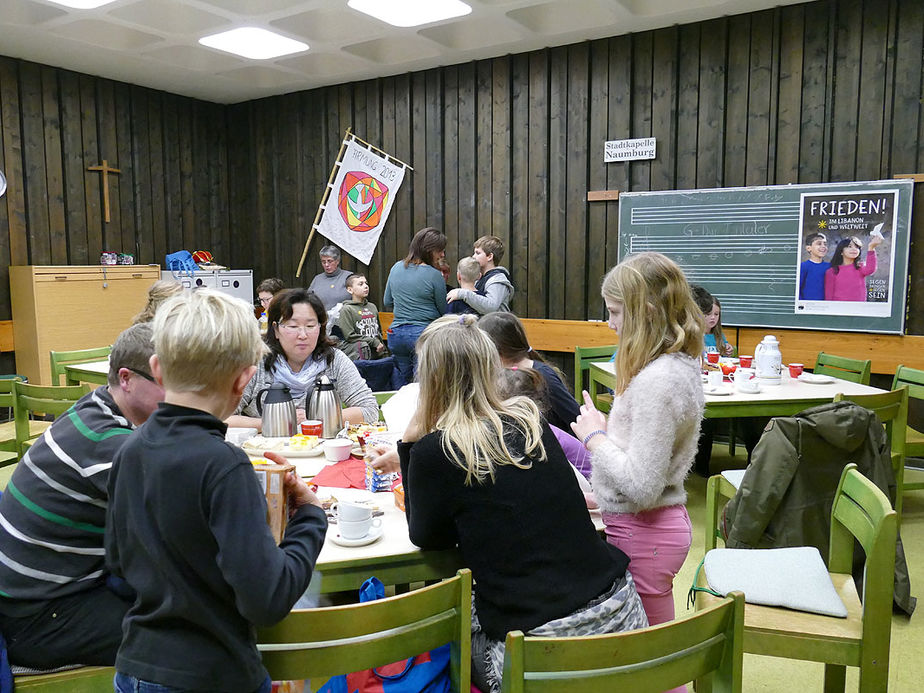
[{"left": 318, "top": 577, "right": 450, "bottom": 693}]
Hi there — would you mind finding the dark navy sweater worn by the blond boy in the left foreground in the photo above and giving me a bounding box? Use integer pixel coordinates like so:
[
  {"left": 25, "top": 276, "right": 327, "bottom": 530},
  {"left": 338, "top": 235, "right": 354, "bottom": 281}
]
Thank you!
[{"left": 106, "top": 403, "right": 327, "bottom": 691}]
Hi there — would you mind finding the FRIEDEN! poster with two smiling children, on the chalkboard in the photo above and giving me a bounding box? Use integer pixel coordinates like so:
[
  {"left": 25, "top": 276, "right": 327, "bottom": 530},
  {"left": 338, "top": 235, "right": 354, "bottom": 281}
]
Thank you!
[{"left": 795, "top": 190, "right": 898, "bottom": 317}]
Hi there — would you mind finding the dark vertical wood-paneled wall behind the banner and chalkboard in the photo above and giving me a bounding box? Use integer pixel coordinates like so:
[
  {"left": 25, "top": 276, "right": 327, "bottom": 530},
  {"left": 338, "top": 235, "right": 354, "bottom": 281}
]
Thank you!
[{"left": 0, "top": 0, "right": 924, "bottom": 334}]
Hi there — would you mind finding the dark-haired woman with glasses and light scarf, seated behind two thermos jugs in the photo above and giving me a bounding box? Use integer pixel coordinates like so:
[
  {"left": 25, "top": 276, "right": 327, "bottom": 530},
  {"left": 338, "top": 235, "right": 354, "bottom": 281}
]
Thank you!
[{"left": 226, "top": 289, "right": 379, "bottom": 430}]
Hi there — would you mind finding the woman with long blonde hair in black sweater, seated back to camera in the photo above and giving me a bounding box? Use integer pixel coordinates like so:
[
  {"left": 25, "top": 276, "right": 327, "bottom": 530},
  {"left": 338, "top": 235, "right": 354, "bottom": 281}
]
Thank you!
[{"left": 398, "top": 315, "right": 647, "bottom": 693}]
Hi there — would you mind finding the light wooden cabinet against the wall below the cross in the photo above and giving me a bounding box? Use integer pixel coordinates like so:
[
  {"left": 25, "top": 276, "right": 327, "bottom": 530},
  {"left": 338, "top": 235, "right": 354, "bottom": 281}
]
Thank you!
[{"left": 10, "top": 265, "right": 160, "bottom": 385}]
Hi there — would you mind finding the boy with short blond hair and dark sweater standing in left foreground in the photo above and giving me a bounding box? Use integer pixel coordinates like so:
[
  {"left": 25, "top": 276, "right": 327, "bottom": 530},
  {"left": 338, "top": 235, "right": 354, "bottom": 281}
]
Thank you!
[{"left": 105, "top": 290, "right": 327, "bottom": 693}]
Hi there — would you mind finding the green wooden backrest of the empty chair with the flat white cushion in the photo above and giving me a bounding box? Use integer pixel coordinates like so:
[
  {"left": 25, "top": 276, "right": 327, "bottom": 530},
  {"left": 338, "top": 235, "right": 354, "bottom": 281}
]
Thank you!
[{"left": 828, "top": 463, "right": 898, "bottom": 652}]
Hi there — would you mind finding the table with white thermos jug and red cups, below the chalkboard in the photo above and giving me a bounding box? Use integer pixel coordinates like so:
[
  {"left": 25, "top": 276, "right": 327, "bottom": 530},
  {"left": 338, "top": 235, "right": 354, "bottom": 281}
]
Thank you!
[{"left": 588, "top": 362, "right": 884, "bottom": 419}]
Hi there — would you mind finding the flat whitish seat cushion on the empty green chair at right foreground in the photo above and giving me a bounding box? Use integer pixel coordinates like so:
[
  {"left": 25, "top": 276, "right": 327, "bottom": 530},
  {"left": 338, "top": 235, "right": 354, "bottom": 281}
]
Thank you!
[{"left": 703, "top": 546, "right": 847, "bottom": 618}]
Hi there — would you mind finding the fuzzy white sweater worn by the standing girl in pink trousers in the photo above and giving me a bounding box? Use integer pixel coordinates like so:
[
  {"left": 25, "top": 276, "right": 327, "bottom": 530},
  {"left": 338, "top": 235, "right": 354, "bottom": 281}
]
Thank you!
[{"left": 591, "top": 354, "right": 704, "bottom": 513}]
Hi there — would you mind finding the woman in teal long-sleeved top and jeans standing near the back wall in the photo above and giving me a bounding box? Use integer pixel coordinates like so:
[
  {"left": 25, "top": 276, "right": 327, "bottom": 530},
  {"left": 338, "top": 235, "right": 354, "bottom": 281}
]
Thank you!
[{"left": 384, "top": 226, "right": 446, "bottom": 383}]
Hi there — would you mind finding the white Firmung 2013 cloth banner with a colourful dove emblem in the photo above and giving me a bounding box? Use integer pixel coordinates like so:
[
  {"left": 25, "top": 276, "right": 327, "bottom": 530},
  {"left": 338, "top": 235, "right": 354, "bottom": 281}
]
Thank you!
[{"left": 317, "top": 136, "right": 405, "bottom": 265}]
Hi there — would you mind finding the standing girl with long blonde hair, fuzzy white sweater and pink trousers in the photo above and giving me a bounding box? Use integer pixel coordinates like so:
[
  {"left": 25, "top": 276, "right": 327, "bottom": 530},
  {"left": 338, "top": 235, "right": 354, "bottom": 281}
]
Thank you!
[{"left": 572, "top": 253, "right": 704, "bottom": 636}]
